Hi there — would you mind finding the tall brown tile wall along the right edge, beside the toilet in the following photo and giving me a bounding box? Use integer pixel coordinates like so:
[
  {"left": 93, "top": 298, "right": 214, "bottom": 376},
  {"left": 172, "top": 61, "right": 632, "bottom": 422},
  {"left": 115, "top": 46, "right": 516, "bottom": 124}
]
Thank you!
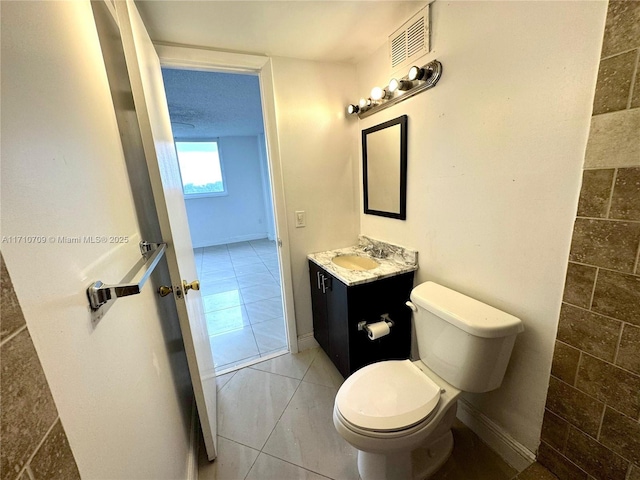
[{"left": 538, "top": 0, "right": 640, "bottom": 480}]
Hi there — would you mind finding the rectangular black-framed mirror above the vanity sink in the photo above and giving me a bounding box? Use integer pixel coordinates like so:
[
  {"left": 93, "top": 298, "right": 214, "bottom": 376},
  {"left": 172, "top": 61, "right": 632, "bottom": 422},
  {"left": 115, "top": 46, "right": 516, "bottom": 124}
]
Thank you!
[{"left": 362, "top": 115, "right": 407, "bottom": 220}]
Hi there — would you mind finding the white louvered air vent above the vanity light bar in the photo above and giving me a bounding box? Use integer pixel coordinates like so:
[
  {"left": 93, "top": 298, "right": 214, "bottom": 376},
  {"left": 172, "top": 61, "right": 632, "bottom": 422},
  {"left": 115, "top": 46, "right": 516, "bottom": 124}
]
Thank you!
[{"left": 389, "top": 5, "right": 430, "bottom": 70}]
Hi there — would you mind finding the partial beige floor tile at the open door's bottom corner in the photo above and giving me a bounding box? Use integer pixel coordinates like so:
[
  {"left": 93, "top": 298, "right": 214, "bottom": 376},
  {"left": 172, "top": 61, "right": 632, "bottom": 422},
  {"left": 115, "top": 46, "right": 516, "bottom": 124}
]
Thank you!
[{"left": 198, "top": 437, "right": 260, "bottom": 480}]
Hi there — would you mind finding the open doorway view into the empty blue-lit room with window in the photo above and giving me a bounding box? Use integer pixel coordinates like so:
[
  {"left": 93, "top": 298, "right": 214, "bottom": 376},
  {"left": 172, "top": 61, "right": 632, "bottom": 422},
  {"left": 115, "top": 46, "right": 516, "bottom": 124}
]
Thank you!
[{"left": 162, "top": 66, "right": 290, "bottom": 374}]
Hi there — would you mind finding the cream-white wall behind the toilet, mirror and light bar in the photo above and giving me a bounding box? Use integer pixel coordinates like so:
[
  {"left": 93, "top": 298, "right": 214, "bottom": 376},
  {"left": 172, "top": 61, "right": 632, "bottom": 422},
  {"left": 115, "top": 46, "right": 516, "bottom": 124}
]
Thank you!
[{"left": 353, "top": 1, "right": 606, "bottom": 458}]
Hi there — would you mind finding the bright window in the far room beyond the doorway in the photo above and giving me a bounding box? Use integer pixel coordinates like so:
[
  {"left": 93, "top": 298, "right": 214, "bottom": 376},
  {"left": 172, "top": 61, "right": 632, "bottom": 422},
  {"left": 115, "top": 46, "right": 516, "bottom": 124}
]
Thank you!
[{"left": 176, "top": 140, "right": 227, "bottom": 198}]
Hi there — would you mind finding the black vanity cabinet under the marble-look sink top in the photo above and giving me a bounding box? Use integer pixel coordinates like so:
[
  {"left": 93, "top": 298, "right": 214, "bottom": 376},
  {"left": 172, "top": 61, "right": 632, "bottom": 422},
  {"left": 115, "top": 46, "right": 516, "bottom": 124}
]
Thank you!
[{"left": 309, "top": 261, "right": 413, "bottom": 378}]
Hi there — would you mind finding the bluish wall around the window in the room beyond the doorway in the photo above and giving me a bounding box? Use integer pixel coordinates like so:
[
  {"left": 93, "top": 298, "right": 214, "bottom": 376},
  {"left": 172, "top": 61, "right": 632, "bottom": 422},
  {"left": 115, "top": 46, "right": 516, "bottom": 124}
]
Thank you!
[{"left": 185, "top": 136, "right": 269, "bottom": 248}]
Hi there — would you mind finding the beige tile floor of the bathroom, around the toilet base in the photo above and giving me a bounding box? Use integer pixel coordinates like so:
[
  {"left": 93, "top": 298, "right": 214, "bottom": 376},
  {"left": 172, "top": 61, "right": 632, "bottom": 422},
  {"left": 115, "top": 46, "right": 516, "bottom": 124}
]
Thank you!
[{"left": 199, "top": 349, "right": 555, "bottom": 480}]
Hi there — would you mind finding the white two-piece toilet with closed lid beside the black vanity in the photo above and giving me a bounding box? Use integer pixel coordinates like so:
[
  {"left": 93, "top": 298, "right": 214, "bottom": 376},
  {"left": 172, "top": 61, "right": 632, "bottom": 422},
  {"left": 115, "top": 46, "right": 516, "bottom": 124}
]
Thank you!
[{"left": 333, "top": 282, "right": 524, "bottom": 480}]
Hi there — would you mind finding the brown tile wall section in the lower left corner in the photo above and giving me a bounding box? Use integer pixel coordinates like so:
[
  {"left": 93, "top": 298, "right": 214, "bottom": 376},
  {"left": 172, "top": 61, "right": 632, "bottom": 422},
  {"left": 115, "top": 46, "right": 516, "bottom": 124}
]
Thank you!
[{"left": 0, "top": 254, "right": 80, "bottom": 480}]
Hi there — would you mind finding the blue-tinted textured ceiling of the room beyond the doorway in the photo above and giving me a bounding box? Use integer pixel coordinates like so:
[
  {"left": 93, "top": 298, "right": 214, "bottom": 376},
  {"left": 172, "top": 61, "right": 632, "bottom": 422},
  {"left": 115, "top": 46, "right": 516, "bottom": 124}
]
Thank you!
[{"left": 162, "top": 68, "right": 264, "bottom": 140}]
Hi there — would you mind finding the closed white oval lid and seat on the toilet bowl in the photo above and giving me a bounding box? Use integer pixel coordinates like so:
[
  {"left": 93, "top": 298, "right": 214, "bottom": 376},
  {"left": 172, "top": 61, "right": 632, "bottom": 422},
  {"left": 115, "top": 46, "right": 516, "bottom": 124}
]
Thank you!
[{"left": 335, "top": 360, "right": 440, "bottom": 432}]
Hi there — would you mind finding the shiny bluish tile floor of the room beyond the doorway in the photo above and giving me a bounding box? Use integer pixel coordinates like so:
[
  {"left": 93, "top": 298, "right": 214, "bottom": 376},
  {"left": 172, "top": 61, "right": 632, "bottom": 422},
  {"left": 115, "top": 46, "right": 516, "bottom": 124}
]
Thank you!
[{"left": 194, "top": 239, "right": 288, "bottom": 372}]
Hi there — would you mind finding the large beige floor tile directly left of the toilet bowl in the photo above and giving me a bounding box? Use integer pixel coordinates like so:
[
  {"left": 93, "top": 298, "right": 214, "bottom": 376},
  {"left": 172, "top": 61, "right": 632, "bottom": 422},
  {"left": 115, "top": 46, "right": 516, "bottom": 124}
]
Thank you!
[{"left": 263, "top": 380, "right": 358, "bottom": 480}]
